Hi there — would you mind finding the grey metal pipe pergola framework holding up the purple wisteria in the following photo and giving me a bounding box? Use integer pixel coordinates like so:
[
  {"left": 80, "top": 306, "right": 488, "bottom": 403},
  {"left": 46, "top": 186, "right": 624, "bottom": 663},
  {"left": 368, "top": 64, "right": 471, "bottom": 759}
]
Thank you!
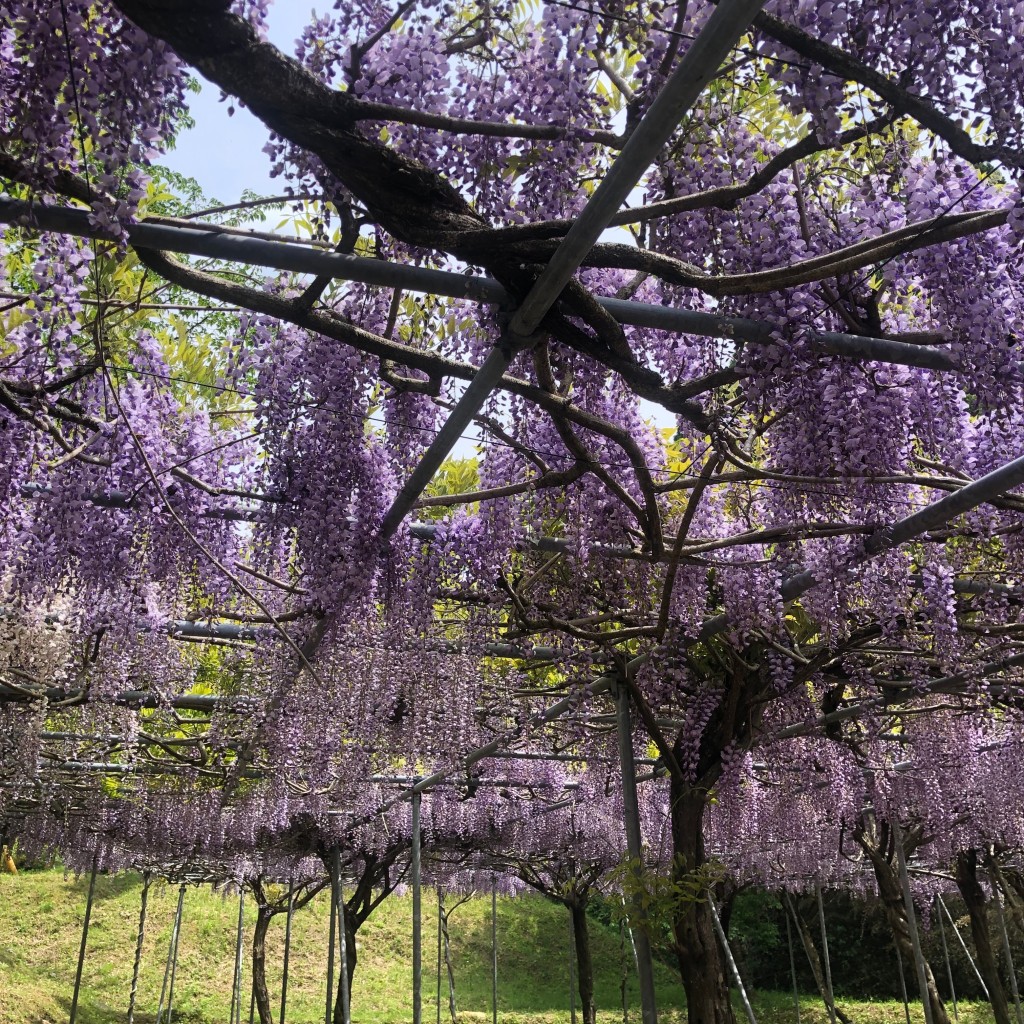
[{"left": 0, "top": 6, "right": 1024, "bottom": 1024}]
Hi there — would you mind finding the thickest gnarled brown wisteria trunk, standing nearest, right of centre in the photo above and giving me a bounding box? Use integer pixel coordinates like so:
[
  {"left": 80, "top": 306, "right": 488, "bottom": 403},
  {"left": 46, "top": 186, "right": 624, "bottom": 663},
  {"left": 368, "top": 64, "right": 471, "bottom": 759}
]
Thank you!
[{"left": 671, "top": 777, "right": 735, "bottom": 1024}]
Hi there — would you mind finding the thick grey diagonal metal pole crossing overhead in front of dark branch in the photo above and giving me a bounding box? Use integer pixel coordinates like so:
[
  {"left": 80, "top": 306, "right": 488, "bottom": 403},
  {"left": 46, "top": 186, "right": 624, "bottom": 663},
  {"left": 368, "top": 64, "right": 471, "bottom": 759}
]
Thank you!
[{"left": 372, "top": 0, "right": 767, "bottom": 540}]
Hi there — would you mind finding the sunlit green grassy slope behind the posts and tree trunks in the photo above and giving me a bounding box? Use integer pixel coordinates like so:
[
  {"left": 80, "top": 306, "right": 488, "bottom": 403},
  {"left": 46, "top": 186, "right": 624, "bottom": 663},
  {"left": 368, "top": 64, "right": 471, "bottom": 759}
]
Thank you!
[{"left": 0, "top": 871, "right": 990, "bottom": 1024}]
